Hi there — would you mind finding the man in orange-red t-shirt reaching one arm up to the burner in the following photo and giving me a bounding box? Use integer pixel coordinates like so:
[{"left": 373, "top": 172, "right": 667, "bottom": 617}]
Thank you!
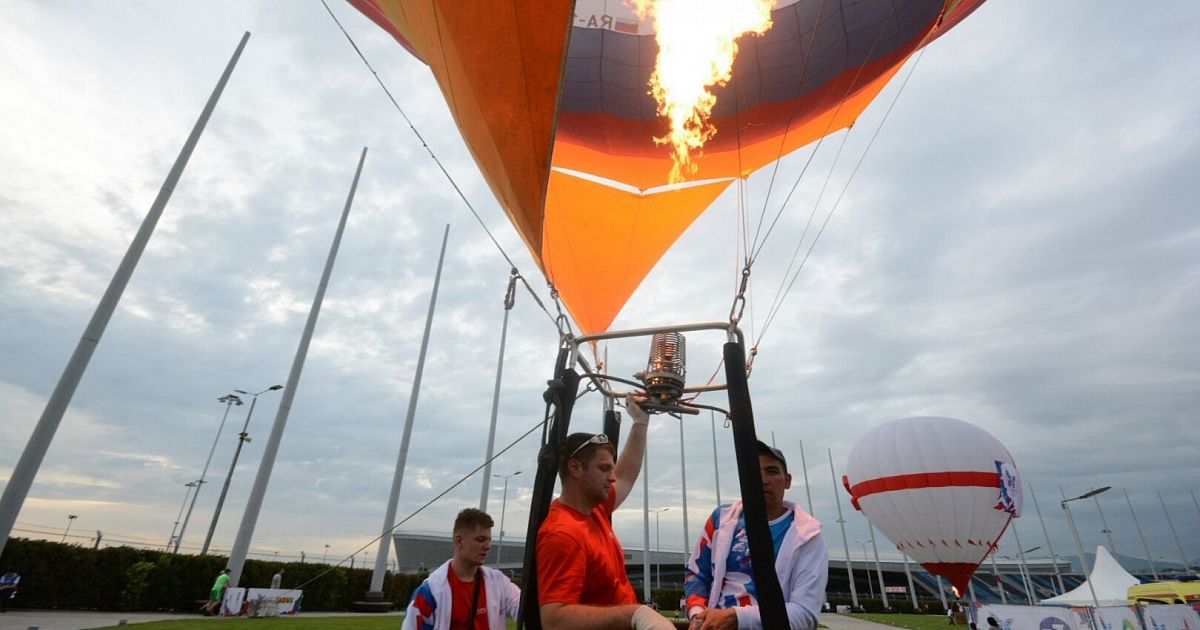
[{"left": 538, "top": 398, "right": 674, "bottom": 630}]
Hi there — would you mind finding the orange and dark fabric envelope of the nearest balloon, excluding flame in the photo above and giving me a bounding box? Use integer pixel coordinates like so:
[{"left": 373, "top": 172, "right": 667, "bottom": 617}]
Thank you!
[{"left": 349, "top": 0, "right": 984, "bottom": 332}]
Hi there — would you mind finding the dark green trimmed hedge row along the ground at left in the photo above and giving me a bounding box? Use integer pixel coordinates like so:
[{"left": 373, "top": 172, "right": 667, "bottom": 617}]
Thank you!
[{"left": 0, "top": 538, "right": 425, "bottom": 611}]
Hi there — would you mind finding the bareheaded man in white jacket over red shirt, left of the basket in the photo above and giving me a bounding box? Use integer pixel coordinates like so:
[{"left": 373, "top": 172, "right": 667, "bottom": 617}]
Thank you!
[{"left": 401, "top": 508, "right": 521, "bottom": 630}]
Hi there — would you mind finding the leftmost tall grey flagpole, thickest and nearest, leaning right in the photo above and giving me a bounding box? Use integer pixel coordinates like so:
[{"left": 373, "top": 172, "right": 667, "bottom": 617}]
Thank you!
[{"left": 0, "top": 31, "right": 250, "bottom": 552}]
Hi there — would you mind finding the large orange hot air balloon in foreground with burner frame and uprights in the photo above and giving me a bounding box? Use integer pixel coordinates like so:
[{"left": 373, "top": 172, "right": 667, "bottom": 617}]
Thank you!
[{"left": 349, "top": 0, "right": 983, "bottom": 629}]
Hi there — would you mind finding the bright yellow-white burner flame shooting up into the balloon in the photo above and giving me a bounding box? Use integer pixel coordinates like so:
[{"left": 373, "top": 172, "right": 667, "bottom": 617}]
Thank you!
[{"left": 634, "top": 0, "right": 775, "bottom": 184}]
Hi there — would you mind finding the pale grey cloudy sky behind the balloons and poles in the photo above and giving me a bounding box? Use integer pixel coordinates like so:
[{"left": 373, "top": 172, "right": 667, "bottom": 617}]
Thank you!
[{"left": 0, "top": 0, "right": 1200, "bottom": 573}]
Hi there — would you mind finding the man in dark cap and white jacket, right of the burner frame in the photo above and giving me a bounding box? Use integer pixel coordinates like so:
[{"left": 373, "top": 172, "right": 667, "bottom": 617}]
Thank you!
[{"left": 684, "top": 442, "right": 829, "bottom": 630}]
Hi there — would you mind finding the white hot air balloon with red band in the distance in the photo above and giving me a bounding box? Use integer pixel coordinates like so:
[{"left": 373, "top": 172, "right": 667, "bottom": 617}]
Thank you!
[{"left": 842, "top": 416, "right": 1021, "bottom": 593}]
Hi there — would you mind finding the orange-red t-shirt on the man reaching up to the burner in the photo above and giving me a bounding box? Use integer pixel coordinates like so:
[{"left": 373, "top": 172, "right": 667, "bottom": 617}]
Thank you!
[{"left": 538, "top": 488, "right": 637, "bottom": 606}]
